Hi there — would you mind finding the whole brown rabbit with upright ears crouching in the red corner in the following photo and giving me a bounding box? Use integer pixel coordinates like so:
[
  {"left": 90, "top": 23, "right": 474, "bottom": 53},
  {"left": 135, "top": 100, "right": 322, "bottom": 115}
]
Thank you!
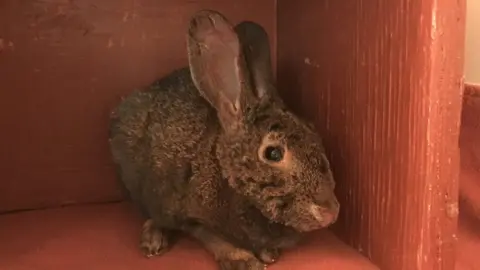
[{"left": 109, "top": 10, "right": 340, "bottom": 270}]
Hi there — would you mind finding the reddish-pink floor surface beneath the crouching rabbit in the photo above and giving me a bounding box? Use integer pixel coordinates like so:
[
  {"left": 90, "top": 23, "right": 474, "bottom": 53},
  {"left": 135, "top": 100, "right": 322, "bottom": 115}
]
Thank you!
[{"left": 0, "top": 203, "right": 378, "bottom": 270}]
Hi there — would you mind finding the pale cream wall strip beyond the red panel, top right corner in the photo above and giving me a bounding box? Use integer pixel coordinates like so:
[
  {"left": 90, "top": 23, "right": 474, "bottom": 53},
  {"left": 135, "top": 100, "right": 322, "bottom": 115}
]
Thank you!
[{"left": 465, "top": 0, "right": 480, "bottom": 84}]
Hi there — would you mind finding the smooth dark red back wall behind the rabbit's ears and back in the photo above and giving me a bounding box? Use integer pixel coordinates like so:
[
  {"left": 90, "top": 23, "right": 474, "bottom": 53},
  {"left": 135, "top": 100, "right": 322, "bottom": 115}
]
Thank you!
[{"left": 0, "top": 0, "right": 275, "bottom": 212}]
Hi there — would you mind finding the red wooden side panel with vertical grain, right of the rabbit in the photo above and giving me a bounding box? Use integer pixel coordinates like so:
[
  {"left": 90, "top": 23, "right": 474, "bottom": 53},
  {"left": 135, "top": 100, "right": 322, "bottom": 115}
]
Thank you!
[{"left": 277, "top": 0, "right": 465, "bottom": 270}]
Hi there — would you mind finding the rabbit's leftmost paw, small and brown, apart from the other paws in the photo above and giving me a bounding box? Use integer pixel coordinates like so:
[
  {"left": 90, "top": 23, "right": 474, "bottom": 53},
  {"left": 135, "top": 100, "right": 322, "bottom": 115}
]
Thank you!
[{"left": 140, "top": 219, "right": 171, "bottom": 257}]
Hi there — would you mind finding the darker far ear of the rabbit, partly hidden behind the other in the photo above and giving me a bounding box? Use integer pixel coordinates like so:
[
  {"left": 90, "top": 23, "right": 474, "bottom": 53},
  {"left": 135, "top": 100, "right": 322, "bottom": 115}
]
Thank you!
[{"left": 235, "top": 21, "right": 275, "bottom": 99}]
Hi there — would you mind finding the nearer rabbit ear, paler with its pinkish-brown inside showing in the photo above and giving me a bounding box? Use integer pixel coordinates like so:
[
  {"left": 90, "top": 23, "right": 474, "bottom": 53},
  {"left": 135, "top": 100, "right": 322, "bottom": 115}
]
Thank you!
[{"left": 187, "top": 10, "right": 248, "bottom": 132}]
